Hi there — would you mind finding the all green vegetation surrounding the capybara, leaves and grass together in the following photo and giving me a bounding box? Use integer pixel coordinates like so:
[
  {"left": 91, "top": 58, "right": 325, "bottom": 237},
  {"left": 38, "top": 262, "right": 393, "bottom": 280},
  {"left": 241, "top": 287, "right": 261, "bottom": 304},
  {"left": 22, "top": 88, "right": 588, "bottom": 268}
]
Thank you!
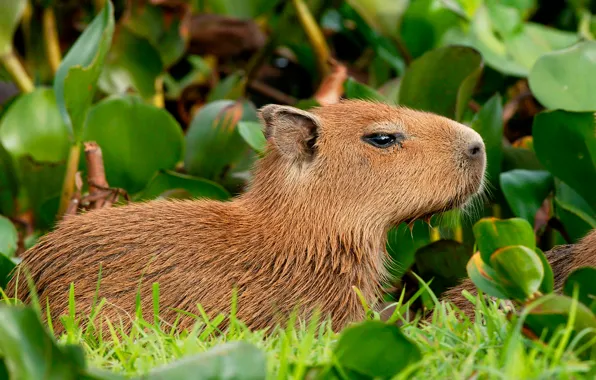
[{"left": 0, "top": 0, "right": 596, "bottom": 379}]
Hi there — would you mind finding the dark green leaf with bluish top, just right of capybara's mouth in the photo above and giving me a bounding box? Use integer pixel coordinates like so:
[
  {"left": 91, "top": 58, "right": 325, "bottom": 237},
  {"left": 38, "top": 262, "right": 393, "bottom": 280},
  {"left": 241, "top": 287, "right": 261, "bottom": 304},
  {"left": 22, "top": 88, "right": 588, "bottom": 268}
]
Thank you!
[{"left": 501, "top": 169, "right": 554, "bottom": 226}]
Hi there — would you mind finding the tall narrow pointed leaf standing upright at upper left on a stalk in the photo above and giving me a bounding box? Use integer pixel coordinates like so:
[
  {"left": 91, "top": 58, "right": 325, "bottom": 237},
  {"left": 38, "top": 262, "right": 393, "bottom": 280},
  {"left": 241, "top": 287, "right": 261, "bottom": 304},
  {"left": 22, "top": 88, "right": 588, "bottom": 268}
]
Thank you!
[{"left": 54, "top": 0, "right": 114, "bottom": 141}]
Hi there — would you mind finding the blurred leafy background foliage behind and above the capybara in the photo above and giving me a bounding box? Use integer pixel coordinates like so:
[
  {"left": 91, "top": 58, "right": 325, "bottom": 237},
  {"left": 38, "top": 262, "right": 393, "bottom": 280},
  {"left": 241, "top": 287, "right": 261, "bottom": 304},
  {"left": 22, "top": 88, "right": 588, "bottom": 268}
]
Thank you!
[{"left": 0, "top": 0, "right": 596, "bottom": 314}]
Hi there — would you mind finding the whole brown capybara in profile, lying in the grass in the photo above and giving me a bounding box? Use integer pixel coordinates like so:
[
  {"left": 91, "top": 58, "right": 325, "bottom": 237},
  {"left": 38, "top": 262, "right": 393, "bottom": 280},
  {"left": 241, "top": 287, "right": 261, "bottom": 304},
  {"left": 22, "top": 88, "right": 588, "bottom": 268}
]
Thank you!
[{"left": 6, "top": 100, "right": 486, "bottom": 333}]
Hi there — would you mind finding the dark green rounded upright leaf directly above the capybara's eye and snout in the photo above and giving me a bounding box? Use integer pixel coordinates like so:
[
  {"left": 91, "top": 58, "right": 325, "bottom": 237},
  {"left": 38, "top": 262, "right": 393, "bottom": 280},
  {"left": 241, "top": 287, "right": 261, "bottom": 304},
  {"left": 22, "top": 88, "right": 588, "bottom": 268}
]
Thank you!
[{"left": 399, "top": 46, "right": 483, "bottom": 121}]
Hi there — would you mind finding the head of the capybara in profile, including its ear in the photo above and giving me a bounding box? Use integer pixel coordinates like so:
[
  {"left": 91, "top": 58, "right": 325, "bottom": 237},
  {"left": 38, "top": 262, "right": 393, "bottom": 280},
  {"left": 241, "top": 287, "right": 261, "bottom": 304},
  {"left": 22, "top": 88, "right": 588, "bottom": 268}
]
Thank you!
[{"left": 254, "top": 100, "right": 486, "bottom": 229}]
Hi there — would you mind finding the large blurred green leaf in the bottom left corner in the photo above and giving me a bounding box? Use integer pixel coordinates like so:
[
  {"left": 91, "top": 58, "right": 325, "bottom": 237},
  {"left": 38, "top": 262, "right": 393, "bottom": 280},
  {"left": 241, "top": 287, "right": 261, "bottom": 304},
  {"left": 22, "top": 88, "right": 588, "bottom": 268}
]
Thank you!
[{"left": 0, "top": 305, "right": 84, "bottom": 380}]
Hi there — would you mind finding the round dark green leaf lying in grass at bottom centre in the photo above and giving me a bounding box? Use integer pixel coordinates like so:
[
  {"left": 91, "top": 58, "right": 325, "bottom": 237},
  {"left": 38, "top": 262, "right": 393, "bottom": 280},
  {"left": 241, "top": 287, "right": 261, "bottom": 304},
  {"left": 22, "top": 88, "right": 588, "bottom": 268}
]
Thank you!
[{"left": 333, "top": 321, "right": 422, "bottom": 378}]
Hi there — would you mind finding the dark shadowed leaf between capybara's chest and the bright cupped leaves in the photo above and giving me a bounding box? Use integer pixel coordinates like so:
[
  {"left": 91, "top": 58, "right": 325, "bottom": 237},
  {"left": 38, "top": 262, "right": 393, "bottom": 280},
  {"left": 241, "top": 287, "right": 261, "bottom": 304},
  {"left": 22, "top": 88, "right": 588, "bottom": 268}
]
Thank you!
[{"left": 415, "top": 240, "right": 473, "bottom": 294}]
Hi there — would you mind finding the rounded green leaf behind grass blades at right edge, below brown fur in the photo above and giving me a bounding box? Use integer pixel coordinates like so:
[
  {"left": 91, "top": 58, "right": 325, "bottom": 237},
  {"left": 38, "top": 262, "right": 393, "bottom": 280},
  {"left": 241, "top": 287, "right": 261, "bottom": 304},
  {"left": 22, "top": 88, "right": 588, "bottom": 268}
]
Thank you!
[{"left": 525, "top": 293, "right": 596, "bottom": 350}]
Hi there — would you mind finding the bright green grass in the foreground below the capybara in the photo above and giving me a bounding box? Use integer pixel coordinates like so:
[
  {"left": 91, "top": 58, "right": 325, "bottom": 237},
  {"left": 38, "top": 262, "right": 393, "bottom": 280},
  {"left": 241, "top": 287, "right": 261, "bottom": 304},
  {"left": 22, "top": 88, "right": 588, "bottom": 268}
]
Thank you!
[{"left": 12, "top": 292, "right": 590, "bottom": 379}]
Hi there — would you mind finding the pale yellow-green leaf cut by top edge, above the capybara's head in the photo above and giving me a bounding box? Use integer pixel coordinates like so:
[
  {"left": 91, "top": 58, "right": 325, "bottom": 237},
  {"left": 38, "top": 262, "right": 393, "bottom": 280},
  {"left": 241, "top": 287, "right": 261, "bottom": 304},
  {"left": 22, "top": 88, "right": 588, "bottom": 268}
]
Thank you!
[{"left": 347, "top": 0, "right": 409, "bottom": 36}]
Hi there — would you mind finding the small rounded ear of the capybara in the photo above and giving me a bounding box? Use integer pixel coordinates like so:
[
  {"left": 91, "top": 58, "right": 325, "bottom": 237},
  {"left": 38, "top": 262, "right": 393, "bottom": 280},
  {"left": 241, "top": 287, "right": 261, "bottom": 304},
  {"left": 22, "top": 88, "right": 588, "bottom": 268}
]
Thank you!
[{"left": 259, "top": 104, "right": 321, "bottom": 161}]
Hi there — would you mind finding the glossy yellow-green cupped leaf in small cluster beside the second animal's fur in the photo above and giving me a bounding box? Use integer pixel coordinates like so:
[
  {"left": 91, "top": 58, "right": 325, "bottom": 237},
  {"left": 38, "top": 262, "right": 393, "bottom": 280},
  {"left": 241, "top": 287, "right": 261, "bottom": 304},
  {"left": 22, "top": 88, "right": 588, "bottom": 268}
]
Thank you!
[{"left": 490, "top": 245, "right": 544, "bottom": 302}]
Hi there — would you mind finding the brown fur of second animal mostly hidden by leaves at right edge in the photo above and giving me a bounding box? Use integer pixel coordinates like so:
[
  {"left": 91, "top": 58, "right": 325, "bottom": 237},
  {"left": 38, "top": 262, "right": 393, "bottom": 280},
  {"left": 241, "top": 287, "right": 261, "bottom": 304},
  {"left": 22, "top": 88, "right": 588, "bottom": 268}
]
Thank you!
[{"left": 441, "top": 230, "right": 596, "bottom": 318}]
